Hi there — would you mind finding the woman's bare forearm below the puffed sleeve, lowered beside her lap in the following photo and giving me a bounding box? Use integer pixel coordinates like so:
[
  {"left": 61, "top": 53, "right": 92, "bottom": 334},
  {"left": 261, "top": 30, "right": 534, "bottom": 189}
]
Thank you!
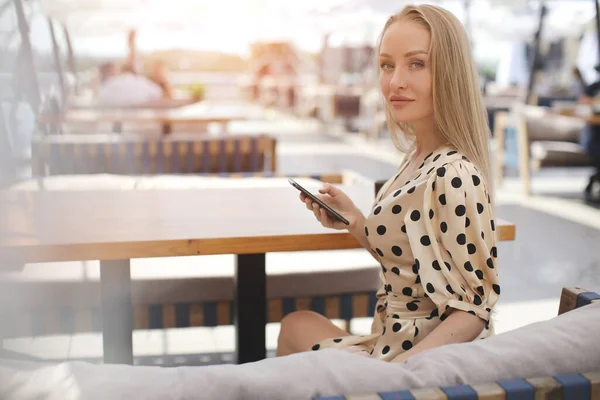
[{"left": 392, "top": 310, "right": 485, "bottom": 362}]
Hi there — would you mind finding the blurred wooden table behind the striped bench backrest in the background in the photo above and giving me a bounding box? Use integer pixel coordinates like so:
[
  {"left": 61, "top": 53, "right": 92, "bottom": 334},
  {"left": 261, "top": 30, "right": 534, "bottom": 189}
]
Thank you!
[{"left": 38, "top": 101, "right": 255, "bottom": 133}]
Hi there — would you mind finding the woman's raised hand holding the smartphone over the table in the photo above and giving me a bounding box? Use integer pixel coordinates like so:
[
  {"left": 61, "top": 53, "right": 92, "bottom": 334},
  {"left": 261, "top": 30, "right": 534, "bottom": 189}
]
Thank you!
[{"left": 300, "top": 183, "right": 364, "bottom": 232}]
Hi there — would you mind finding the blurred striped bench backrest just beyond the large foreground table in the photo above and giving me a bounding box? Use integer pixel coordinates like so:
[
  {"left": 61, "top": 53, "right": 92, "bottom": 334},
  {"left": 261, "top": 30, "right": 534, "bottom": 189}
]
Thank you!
[{"left": 32, "top": 134, "right": 276, "bottom": 176}]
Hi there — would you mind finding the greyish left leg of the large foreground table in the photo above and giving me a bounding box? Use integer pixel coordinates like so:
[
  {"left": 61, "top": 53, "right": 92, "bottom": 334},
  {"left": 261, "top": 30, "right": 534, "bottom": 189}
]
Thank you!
[{"left": 100, "top": 260, "right": 133, "bottom": 364}]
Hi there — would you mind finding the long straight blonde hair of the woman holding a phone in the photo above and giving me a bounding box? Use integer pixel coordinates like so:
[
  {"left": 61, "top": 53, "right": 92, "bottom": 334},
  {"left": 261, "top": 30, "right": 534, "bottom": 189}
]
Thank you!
[{"left": 377, "top": 5, "right": 492, "bottom": 192}]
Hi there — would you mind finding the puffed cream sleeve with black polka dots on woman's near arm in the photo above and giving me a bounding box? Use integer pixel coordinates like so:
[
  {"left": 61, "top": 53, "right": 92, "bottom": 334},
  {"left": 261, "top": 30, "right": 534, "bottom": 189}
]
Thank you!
[{"left": 407, "top": 160, "right": 500, "bottom": 322}]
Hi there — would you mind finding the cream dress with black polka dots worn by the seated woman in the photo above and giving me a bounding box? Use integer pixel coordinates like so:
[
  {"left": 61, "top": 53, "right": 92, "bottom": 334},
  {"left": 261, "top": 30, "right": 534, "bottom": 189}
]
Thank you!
[{"left": 313, "top": 145, "right": 500, "bottom": 361}]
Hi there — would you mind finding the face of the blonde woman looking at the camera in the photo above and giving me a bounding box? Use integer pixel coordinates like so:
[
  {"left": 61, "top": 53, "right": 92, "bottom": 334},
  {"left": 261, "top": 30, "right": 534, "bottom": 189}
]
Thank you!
[{"left": 379, "top": 20, "right": 433, "bottom": 123}]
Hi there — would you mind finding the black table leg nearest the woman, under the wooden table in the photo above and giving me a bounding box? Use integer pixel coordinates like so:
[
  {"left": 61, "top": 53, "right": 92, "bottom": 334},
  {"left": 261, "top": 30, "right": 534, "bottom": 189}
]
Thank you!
[{"left": 235, "top": 253, "right": 267, "bottom": 364}]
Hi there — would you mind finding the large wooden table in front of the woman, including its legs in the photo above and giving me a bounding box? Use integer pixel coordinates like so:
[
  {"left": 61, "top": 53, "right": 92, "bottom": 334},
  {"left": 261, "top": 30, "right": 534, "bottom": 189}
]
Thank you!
[{"left": 0, "top": 186, "right": 515, "bottom": 364}]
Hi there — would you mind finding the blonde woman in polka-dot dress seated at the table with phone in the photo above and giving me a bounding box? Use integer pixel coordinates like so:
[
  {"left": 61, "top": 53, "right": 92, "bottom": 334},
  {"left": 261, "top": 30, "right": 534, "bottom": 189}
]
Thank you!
[{"left": 277, "top": 5, "right": 500, "bottom": 362}]
